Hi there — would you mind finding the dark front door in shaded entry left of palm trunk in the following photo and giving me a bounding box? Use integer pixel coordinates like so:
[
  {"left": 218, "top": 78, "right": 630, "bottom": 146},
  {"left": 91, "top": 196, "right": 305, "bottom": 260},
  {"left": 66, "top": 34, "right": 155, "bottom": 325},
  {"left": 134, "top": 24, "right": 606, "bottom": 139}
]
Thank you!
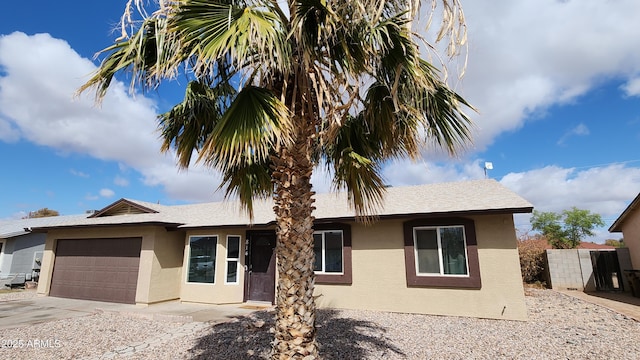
[{"left": 245, "top": 231, "right": 276, "bottom": 303}]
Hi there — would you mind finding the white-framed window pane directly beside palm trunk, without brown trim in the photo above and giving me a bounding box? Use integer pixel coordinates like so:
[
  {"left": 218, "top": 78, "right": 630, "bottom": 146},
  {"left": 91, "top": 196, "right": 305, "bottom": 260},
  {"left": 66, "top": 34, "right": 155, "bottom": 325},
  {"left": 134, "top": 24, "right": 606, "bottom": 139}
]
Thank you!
[{"left": 313, "top": 230, "right": 344, "bottom": 274}]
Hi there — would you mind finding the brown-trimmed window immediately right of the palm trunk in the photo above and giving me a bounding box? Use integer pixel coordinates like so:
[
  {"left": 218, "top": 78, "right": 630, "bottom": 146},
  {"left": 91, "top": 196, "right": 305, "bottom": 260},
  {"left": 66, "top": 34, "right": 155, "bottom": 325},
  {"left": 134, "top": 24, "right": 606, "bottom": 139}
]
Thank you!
[{"left": 313, "top": 223, "right": 351, "bottom": 284}]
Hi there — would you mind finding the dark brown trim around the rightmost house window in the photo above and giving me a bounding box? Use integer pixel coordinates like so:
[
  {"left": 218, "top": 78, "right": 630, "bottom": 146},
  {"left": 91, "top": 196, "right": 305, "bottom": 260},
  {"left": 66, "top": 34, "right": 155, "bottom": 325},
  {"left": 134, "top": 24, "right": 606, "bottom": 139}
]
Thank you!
[{"left": 403, "top": 218, "right": 482, "bottom": 289}]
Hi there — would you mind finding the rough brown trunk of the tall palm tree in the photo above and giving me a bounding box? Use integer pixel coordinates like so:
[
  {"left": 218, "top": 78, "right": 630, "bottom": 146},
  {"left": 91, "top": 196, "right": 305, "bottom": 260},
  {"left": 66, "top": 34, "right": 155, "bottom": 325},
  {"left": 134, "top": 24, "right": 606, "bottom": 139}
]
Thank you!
[{"left": 271, "top": 117, "right": 318, "bottom": 360}]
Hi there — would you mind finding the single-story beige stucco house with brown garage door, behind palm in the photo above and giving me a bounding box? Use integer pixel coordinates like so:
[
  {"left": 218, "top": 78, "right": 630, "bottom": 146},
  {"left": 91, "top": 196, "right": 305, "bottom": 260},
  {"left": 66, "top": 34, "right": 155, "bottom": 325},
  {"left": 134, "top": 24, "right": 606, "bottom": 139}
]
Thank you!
[{"left": 34, "top": 180, "right": 532, "bottom": 320}]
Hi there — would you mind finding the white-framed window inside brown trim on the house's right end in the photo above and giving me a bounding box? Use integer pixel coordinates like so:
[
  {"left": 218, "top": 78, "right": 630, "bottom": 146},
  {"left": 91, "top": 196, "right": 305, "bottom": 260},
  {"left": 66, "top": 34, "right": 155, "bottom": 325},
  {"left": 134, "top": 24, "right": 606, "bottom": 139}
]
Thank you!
[{"left": 413, "top": 225, "right": 469, "bottom": 276}]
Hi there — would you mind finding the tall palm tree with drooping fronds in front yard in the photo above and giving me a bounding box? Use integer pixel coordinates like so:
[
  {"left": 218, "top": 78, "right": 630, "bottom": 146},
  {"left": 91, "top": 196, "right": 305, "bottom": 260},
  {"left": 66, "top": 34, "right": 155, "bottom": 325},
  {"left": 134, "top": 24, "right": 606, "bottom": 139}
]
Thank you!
[{"left": 79, "top": 0, "right": 471, "bottom": 359}]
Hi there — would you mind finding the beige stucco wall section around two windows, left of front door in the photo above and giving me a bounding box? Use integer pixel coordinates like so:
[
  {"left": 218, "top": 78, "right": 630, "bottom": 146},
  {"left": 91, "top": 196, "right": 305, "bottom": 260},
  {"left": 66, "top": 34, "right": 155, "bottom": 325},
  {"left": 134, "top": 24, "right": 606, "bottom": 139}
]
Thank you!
[{"left": 180, "top": 229, "right": 246, "bottom": 304}]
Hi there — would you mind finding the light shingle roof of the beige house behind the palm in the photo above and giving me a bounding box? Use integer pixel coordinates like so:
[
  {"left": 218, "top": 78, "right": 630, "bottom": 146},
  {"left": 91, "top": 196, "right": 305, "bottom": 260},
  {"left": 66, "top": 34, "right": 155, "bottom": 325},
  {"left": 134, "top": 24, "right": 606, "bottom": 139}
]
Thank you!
[{"left": 30, "top": 180, "right": 533, "bottom": 229}]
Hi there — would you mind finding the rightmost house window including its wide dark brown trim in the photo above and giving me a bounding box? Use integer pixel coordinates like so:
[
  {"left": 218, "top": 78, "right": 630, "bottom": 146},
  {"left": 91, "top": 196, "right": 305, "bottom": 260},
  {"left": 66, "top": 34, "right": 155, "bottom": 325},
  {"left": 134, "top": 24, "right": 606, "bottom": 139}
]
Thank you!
[{"left": 404, "top": 218, "right": 481, "bottom": 288}]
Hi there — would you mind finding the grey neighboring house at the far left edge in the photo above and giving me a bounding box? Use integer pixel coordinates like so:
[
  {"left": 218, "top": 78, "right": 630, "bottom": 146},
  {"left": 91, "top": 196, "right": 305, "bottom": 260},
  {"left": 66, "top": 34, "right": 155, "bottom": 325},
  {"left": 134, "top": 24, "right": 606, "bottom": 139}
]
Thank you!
[{"left": 0, "top": 215, "right": 86, "bottom": 280}]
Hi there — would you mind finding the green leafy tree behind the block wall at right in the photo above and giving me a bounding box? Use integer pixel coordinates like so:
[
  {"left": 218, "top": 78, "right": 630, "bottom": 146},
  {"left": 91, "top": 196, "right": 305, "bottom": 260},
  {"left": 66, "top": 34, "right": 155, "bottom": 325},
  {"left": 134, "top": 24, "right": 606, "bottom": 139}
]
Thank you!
[{"left": 531, "top": 206, "right": 604, "bottom": 249}]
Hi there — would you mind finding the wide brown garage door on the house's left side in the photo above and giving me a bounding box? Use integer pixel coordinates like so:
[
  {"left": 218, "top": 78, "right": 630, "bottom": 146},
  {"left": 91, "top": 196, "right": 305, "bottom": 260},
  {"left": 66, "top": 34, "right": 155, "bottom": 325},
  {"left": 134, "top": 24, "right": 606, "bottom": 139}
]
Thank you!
[{"left": 49, "top": 238, "right": 142, "bottom": 304}]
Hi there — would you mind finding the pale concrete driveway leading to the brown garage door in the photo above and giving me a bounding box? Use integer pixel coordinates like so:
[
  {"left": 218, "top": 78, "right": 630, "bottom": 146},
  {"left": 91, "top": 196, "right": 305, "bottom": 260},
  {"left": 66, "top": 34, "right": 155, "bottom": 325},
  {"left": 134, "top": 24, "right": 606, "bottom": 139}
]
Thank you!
[{"left": 0, "top": 296, "right": 270, "bottom": 329}]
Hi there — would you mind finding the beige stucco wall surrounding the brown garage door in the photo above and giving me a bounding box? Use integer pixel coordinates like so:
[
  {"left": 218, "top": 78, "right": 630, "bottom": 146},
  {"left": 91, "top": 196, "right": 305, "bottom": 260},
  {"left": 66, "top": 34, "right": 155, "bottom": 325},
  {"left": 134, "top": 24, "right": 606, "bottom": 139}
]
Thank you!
[{"left": 38, "top": 226, "right": 184, "bottom": 304}]
